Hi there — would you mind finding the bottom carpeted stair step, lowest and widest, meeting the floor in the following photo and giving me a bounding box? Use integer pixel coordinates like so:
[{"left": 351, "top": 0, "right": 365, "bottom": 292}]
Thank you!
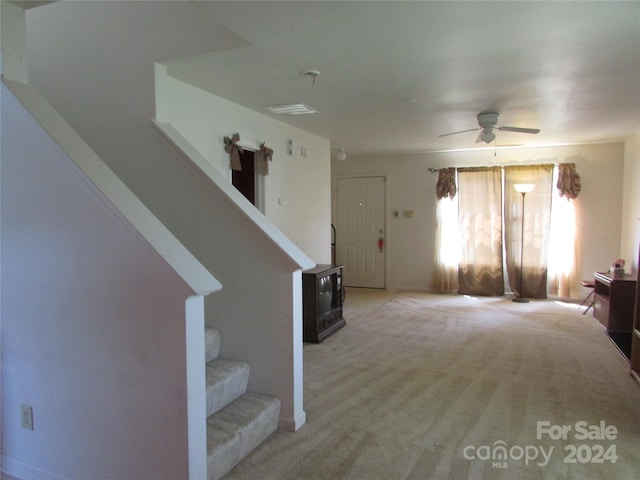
[{"left": 207, "top": 392, "right": 280, "bottom": 480}]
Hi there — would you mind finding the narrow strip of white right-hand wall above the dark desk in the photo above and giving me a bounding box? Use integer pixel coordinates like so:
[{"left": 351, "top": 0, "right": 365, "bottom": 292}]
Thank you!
[{"left": 621, "top": 130, "right": 640, "bottom": 274}]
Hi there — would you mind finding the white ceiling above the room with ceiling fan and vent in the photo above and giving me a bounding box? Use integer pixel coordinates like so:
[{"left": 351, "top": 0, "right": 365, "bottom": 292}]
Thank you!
[{"left": 20, "top": 1, "right": 640, "bottom": 153}]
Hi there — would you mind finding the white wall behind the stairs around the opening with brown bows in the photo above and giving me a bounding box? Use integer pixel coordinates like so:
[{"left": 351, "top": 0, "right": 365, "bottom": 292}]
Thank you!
[{"left": 157, "top": 73, "right": 331, "bottom": 263}]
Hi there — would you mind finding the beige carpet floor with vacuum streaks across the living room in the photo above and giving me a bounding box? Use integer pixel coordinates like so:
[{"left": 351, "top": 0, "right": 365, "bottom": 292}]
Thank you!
[{"left": 225, "top": 289, "right": 640, "bottom": 480}]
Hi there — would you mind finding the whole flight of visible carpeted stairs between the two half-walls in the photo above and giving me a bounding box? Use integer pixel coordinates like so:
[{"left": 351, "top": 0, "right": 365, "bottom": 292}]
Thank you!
[{"left": 205, "top": 328, "right": 280, "bottom": 480}]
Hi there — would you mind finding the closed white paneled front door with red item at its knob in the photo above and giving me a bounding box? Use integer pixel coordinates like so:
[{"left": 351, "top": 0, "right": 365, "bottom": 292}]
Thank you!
[{"left": 336, "top": 177, "right": 385, "bottom": 288}]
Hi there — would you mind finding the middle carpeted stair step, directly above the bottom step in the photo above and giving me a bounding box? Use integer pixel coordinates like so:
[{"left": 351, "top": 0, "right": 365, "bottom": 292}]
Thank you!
[{"left": 206, "top": 358, "right": 249, "bottom": 417}]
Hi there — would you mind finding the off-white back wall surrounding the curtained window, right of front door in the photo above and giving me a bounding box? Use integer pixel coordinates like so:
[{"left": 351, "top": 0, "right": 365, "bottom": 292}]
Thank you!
[{"left": 332, "top": 143, "right": 624, "bottom": 290}]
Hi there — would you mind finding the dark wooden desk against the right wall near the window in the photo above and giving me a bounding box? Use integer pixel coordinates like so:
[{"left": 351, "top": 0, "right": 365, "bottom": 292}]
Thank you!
[{"left": 593, "top": 272, "right": 636, "bottom": 332}]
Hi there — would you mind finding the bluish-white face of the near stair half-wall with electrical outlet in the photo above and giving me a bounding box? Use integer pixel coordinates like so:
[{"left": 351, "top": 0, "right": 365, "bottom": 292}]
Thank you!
[{"left": 1, "top": 81, "right": 198, "bottom": 480}]
